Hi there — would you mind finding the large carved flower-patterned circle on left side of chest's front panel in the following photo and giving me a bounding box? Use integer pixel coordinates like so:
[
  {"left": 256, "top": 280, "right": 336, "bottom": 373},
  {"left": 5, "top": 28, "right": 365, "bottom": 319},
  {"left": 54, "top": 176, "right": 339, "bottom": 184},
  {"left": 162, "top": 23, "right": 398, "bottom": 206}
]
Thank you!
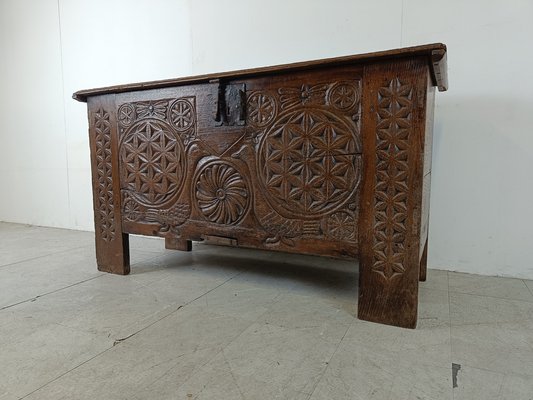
[{"left": 120, "top": 119, "right": 185, "bottom": 206}]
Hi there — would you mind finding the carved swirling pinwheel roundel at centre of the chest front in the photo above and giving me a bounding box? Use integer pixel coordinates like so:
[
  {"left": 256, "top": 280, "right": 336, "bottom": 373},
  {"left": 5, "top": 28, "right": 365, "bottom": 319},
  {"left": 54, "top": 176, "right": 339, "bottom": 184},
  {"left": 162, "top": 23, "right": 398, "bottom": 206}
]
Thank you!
[{"left": 193, "top": 160, "right": 250, "bottom": 225}]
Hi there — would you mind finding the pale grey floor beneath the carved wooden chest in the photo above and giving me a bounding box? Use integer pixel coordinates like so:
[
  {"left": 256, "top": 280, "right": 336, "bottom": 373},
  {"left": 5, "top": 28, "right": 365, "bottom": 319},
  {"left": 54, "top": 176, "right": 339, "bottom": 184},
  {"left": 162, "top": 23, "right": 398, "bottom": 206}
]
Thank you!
[{"left": 0, "top": 223, "right": 533, "bottom": 400}]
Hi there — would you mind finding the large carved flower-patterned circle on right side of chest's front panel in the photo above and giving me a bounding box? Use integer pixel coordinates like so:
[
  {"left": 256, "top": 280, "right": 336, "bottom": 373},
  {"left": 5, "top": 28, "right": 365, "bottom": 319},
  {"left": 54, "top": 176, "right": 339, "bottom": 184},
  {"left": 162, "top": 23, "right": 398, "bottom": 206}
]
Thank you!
[{"left": 258, "top": 108, "right": 360, "bottom": 218}]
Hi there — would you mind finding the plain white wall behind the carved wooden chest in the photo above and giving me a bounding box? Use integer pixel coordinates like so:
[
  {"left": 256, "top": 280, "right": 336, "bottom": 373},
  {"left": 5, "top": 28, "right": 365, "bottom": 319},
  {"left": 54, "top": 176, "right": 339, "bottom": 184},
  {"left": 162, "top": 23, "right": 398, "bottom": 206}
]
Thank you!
[{"left": 0, "top": 0, "right": 533, "bottom": 279}]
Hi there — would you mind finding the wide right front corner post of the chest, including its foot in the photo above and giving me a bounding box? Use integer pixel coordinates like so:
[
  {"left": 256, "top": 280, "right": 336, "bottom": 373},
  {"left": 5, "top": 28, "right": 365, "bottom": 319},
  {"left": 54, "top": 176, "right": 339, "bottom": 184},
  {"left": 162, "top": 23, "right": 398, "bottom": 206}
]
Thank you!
[{"left": 358, "top": 58, "right": 429, "bottom": 328}]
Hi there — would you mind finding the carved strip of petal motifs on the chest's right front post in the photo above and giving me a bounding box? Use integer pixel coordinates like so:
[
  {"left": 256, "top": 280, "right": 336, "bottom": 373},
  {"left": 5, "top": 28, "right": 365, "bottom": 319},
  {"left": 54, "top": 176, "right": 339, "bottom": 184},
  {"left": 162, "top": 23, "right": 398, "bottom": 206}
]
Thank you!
[{"left": 372, "top": 78, "right": 413, "bottom": 279}]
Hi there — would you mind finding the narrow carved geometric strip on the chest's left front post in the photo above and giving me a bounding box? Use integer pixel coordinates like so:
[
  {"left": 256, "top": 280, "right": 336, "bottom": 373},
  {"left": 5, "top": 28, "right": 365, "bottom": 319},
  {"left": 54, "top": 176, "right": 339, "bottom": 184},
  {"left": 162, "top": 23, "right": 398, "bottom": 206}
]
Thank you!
[{"left": 93, "top": 108, "right": 115, "bottom": 242}]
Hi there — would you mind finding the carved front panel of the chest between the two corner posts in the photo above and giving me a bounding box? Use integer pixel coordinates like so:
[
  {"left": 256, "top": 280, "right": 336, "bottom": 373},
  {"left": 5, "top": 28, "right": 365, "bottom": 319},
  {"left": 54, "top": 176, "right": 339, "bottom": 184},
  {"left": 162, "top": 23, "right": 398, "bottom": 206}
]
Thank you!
[{"left": 117, "top": 67, "right": 362, "bottom": 257}]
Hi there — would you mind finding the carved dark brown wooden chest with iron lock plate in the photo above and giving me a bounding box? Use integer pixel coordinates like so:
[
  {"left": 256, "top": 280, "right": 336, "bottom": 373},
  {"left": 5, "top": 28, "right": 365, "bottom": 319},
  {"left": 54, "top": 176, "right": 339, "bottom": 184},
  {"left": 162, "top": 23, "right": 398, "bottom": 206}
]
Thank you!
[{"left": 74, "top": 44, "right": 447, "bottom": 328}]
